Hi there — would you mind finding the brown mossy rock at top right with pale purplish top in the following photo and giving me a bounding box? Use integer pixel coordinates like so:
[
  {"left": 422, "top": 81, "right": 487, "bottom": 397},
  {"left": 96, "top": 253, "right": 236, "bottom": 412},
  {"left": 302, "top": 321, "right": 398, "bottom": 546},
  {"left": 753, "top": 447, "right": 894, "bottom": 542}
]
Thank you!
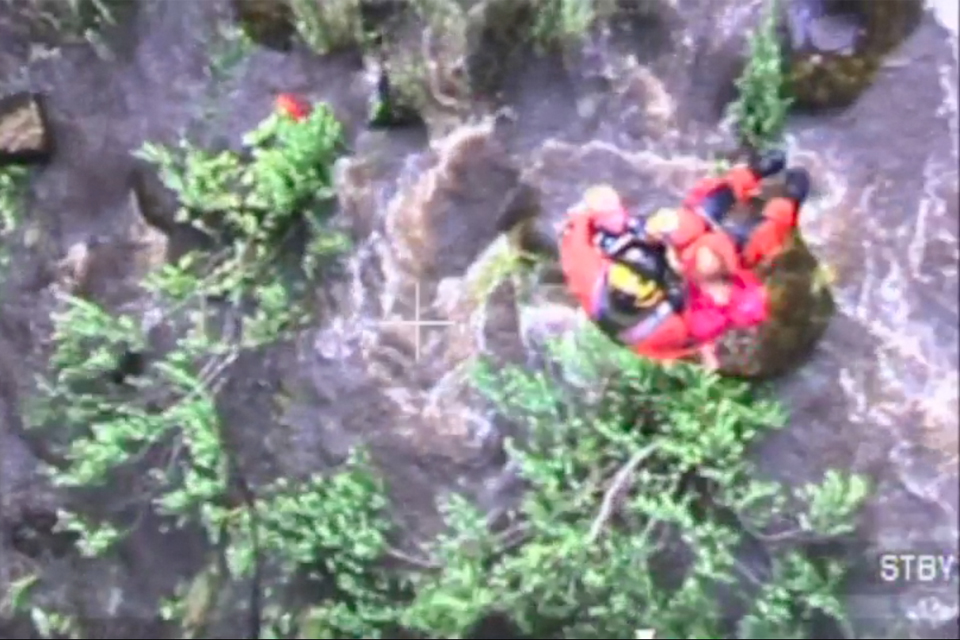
[{"left": 782, "top": 0, "right": 923, "bottom": 109}]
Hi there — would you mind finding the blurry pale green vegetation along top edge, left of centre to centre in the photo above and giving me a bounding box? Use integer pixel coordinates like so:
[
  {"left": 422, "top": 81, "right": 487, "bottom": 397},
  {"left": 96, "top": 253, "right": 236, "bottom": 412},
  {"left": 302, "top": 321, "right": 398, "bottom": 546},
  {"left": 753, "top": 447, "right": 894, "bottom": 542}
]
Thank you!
[{"left": 290, "top": 0, "right": 616, "bottom": 120}]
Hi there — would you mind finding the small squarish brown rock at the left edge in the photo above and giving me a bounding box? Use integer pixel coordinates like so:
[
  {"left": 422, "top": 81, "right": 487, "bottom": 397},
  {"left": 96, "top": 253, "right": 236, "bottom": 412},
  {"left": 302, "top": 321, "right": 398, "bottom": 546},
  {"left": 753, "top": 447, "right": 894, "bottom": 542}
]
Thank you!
[{"left": 0, "top": 92, "right": 53, "bottom": 165}]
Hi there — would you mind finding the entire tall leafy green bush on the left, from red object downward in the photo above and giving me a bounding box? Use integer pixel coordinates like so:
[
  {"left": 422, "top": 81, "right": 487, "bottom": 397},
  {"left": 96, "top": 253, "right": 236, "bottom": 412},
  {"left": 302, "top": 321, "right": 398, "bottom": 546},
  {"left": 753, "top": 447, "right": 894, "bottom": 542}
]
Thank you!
[{"left": 19, "top": 101, "right": 347, "bottom": 636}]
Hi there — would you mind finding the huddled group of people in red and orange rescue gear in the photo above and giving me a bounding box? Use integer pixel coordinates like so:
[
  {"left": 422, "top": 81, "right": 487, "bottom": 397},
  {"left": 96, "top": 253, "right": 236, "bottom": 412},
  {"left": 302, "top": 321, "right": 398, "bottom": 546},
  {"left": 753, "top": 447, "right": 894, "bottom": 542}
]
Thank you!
[{"left": 560, "top": 151, "right": 810, "bottom": 370}]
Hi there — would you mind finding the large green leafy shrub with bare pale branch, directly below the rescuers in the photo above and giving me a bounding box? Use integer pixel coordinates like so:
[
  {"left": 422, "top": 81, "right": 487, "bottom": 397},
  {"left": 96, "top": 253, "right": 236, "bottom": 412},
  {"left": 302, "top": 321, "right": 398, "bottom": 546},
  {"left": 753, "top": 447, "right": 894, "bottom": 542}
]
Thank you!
[{"left": 404, "top": 330, "right": 866, "bottom": 638}]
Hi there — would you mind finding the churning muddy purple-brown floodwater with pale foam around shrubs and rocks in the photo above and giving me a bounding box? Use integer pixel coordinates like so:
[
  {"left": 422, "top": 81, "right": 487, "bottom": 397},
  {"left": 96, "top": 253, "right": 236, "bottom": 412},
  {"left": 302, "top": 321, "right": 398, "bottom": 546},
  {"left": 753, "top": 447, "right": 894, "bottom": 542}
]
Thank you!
[{"left": 0, "top": 0, "right": 960, "bottom": 637}]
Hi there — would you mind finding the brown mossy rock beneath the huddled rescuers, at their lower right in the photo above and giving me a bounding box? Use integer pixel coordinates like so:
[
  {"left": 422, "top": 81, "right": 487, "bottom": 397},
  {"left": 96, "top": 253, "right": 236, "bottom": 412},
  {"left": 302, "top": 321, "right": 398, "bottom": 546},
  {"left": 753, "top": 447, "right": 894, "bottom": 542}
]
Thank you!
[{"left": 719, "top": 236, "right": 835, "bottom": 378}]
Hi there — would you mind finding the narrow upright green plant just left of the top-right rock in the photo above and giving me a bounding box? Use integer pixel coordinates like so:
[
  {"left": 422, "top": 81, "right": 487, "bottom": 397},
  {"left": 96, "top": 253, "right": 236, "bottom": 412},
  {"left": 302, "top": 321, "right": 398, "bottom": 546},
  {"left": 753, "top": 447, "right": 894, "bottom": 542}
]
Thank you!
[{"left": 731, "top": 0, "right": 792, "bottom": 150}]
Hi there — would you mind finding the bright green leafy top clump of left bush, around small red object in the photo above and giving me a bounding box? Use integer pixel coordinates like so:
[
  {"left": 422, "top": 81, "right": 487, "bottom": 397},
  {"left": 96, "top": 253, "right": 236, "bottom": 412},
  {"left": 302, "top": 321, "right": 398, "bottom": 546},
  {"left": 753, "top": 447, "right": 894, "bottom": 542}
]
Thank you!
[{"left": 138, "top": 98, "right": 348, "bottom": 282}]
